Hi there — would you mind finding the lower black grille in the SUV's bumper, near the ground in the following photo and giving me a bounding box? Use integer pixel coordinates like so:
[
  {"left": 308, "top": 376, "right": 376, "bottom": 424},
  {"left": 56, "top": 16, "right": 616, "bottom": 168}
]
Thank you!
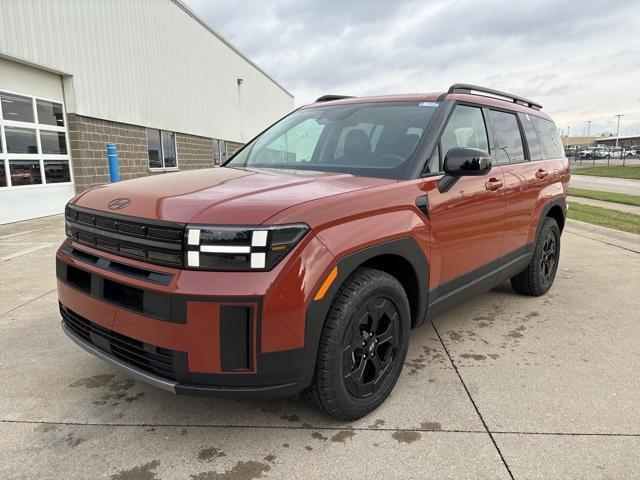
[{"left": 60, "top": 304, "right": 176, "bottom": 380}]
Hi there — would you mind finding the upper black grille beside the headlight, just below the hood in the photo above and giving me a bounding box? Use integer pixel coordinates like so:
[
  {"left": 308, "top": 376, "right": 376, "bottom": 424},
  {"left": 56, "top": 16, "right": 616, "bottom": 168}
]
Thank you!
[{"left": 65, "top": 205, "right": 185, "bottom": 267}]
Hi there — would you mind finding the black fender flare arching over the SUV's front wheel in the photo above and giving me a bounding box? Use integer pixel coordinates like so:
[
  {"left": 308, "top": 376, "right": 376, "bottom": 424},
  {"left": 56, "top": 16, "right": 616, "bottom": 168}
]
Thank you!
[{"left": 305, "top": 237, "right": 429, "bottom": 368}]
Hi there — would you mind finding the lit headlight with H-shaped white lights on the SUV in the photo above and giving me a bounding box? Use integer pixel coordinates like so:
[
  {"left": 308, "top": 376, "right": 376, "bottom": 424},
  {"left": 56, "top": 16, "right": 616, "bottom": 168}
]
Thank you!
[{"left": 185, "top": 224, "right": 309, "bottom": 271}]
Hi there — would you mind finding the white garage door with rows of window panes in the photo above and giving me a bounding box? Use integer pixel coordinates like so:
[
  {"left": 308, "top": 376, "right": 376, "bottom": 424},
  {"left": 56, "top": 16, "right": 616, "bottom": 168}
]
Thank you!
[{"left": 0, "top": 60, "right": 74, "bottom": 223}]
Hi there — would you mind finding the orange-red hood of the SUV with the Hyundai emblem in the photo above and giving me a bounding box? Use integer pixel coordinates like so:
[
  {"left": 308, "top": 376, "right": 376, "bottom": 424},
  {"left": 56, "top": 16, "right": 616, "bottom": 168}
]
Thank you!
[{"left": 71, "top": 167, "right": 393, "bottom": 225}]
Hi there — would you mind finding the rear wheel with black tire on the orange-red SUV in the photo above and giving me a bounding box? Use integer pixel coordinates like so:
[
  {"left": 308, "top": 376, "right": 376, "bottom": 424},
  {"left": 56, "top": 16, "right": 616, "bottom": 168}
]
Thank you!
[{"left": 511, "top": 217, "right": 560, "bottom": 297}]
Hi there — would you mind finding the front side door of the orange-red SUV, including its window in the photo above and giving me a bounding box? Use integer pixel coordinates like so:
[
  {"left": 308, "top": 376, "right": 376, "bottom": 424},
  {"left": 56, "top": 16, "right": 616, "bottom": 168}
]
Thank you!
[{"left": 428, "top": 105, "right": 505, "bottom": 297}]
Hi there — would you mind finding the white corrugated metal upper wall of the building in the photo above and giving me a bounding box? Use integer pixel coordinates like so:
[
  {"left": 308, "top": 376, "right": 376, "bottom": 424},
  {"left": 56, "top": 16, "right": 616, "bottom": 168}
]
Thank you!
[{"left": 0, "top": 0, "right": 293, "bottom": 142}]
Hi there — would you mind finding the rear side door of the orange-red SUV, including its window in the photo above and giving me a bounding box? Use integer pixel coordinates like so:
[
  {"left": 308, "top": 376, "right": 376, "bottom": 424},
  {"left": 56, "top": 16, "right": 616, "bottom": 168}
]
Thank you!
[{"left": 488, "top": 109, "right": 548, "bottom": 258}]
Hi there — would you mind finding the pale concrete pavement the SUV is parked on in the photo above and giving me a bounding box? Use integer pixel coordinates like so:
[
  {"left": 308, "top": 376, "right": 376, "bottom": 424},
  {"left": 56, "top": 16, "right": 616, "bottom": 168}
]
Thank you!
[{"left": 0, "top": 217, "right": 640, "bottom": 480}]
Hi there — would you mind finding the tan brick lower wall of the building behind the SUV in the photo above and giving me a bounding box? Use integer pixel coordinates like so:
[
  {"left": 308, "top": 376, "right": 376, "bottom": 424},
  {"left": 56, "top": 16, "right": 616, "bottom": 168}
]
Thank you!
[{"left": 67, "top": 113, "right": 218, "bottom": 193}]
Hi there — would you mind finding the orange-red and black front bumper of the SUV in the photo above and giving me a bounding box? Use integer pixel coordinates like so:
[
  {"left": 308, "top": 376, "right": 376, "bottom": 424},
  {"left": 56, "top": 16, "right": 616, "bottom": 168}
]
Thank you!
[{"left": 56, "top": 233, "right": 333, "bottom": 398}]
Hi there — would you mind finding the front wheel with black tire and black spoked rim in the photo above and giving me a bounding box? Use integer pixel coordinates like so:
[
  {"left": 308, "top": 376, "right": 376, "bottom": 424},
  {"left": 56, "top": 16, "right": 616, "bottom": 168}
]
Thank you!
[{"left": 302, "top": 268, "right": 411, "bottom": 421}]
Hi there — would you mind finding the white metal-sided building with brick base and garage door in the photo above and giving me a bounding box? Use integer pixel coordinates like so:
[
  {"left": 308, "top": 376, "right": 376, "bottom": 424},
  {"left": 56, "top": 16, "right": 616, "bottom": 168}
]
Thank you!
[{"left": 0, "top": 0, "right": 293, "bottom": 223}]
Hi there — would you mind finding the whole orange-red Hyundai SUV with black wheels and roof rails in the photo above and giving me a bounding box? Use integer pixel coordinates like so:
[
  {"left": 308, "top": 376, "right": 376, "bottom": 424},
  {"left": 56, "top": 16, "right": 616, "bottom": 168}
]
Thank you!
[{"left": 56, "top": 84, "right": 569, "bottom": 420}]
